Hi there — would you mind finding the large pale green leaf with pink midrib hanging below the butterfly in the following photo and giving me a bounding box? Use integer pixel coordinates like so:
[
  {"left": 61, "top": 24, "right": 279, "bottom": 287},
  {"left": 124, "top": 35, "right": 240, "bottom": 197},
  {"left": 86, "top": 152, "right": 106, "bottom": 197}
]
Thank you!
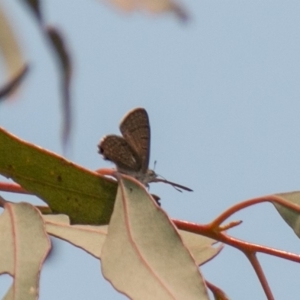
[{"left": 101, "top": 176, "right": 208, "bottom": 300}]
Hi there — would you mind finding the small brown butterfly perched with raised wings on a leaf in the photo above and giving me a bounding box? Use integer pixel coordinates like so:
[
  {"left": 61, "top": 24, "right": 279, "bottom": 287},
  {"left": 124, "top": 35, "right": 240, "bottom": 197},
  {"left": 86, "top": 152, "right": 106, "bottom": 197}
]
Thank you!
[{"left": 98, "top": 108, "right": 192, "bottom": 191}]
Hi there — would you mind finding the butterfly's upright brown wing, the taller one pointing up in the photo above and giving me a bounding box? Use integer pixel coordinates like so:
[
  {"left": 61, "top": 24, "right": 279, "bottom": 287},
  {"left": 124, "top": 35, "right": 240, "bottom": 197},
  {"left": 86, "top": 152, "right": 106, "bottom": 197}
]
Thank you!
[{"left": 120, "top": 108, "right": 150, "bottom": 174}]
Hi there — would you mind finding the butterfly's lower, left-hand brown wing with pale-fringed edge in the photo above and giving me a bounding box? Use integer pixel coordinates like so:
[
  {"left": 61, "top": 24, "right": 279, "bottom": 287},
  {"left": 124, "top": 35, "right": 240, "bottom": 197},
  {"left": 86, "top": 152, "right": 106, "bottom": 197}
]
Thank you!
[{"left": 98, "top": 135, "right": 141, "bottom": 173}]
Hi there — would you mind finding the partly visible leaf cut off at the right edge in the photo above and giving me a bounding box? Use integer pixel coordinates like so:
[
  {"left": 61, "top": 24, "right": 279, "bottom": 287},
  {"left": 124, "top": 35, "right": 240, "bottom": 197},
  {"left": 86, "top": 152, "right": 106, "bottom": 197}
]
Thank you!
[{"left": 273, "top": 191, "right": 300, "bottom": 238}]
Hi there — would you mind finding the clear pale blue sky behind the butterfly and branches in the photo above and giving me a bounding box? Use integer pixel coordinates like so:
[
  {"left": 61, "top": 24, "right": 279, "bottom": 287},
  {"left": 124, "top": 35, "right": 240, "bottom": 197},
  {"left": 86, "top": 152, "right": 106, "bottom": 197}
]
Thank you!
[{"left": 0, "top": 0, "right": 300, "bottom": 300}]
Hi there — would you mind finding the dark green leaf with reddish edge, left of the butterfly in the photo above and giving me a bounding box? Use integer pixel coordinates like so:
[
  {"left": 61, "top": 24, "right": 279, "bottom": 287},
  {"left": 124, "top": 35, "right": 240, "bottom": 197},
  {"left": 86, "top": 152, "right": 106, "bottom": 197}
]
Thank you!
[{"left": 0, "top": 128, "right": 117, "bottom": 225}]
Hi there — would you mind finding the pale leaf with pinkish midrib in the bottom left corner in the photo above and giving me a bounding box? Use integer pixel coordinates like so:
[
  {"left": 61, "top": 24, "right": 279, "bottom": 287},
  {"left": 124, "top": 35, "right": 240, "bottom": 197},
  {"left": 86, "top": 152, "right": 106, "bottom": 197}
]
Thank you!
[{"left": 0, "top": 203, "right": 51, "bottom": 300}]
